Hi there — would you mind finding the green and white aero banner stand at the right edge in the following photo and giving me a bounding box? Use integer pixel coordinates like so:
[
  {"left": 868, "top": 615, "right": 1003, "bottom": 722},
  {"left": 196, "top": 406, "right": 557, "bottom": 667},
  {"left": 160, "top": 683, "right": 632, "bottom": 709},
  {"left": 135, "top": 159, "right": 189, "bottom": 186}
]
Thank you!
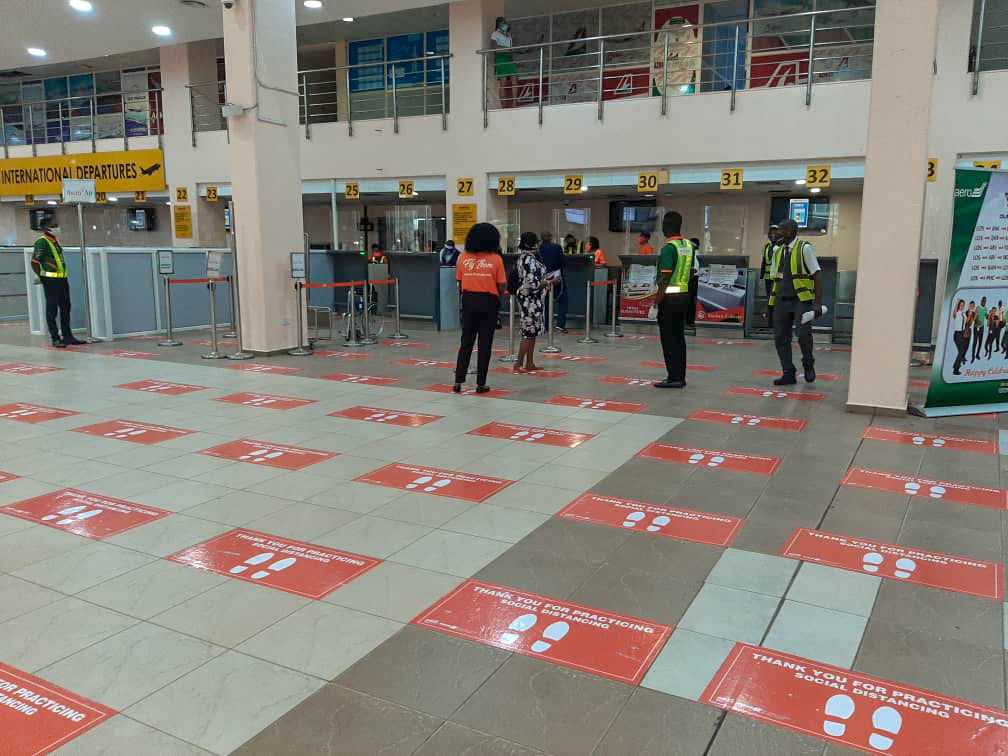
[{"left": 915, "top": 168, "right": 1008, "bottom": 417}]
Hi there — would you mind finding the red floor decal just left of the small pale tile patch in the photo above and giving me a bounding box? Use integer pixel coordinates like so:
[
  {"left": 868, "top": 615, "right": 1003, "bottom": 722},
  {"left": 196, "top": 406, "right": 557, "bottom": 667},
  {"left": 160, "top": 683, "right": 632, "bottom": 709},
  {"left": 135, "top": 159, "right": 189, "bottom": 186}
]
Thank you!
[{"left": 412, "top": 580, "right": 672, "bottom": 685}]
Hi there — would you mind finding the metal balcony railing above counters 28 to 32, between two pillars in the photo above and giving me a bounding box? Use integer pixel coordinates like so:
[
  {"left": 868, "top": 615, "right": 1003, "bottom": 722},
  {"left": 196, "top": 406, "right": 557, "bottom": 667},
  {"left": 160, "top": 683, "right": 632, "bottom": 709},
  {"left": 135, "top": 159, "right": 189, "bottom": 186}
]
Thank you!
[{"left": 477, "top": 4, "right": 875, "bottom": 127}]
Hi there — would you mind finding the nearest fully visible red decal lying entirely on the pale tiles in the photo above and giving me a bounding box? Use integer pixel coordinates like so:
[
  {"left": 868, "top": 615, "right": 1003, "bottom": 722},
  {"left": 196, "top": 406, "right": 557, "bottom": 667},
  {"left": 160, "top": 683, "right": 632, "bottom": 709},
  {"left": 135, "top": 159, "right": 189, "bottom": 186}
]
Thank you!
[{"left": 166, "top": 528, "right": 382, "bottom": 599}]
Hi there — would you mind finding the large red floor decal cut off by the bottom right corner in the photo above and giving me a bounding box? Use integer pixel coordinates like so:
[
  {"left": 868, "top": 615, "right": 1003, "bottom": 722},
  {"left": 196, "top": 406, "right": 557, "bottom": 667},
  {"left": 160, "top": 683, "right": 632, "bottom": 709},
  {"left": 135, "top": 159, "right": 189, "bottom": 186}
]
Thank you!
[{"left": 700, "top": 643, "right": 1008, "bottom": 756}]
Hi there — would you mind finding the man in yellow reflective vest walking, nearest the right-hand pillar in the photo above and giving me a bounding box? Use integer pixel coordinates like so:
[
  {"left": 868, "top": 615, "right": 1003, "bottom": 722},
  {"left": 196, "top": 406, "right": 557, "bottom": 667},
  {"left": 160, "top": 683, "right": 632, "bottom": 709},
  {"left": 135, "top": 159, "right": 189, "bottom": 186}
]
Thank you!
[{"left": 770, "top": 219, "right": 826, "bottom": 386}]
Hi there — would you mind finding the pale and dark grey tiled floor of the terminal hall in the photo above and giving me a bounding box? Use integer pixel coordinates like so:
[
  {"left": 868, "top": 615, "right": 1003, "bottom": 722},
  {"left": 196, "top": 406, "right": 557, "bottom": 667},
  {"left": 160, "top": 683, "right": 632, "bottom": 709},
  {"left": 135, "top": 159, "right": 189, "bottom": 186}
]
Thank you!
[{"left": 0, "top": 325, "right": 1008, "bottom": 756}]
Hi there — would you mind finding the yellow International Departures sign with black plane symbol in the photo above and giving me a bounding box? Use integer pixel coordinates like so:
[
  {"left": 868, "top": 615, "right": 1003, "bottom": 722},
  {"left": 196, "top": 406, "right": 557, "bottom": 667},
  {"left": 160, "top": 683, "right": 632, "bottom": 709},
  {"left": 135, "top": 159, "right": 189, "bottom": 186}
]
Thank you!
[{"left": 0, "top": 149, "right": 165, "bottom": 197}]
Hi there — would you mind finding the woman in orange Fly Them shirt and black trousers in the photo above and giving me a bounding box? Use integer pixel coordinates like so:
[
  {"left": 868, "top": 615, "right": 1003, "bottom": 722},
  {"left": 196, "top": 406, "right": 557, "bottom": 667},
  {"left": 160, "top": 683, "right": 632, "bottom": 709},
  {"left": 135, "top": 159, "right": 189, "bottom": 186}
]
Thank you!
[{"left": 452, "top": 223, "right": 507, "bottom": 394}]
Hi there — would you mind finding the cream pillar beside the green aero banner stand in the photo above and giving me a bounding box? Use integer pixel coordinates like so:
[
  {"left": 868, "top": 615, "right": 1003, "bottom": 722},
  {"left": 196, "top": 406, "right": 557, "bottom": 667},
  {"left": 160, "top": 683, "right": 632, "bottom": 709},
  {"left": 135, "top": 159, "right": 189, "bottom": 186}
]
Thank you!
[{"left": 848, "top": 0, "right": 938, "bottom": 412}]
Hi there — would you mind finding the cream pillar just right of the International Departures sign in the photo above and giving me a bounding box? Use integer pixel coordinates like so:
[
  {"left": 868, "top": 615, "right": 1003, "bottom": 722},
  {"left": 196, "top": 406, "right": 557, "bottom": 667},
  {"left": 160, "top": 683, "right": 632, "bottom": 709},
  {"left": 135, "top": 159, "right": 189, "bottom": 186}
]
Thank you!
[{"left": 224, "top": 0, "right": 304, "bottom": 353}]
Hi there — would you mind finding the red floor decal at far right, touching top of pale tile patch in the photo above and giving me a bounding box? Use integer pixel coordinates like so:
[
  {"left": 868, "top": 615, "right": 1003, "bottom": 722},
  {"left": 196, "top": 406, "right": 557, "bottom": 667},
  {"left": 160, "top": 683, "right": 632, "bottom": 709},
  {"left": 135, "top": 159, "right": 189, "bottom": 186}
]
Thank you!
[{"left": 780, "top": 527, "right": 1004, "bottom": 601}]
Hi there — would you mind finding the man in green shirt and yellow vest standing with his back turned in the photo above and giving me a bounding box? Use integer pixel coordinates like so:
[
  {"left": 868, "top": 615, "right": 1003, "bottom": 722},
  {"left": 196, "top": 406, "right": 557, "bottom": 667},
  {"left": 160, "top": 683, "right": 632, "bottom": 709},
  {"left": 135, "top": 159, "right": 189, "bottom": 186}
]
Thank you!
[{"left": 649, "top": 211, "right": 698, "bottom": 388}]
